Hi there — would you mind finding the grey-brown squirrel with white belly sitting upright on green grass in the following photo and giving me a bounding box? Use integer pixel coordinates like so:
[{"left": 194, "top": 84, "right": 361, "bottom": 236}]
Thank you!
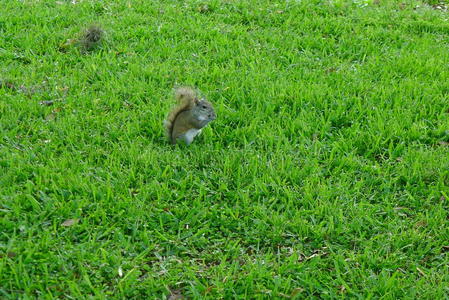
[{"left": 164, "top": 87, "right": 217, "bottom": 145}]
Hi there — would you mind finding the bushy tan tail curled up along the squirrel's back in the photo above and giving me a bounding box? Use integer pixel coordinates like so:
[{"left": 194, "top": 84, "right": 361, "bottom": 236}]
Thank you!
[{"left": 164, "top": 87, "right": 196, "bottom": 143}]
